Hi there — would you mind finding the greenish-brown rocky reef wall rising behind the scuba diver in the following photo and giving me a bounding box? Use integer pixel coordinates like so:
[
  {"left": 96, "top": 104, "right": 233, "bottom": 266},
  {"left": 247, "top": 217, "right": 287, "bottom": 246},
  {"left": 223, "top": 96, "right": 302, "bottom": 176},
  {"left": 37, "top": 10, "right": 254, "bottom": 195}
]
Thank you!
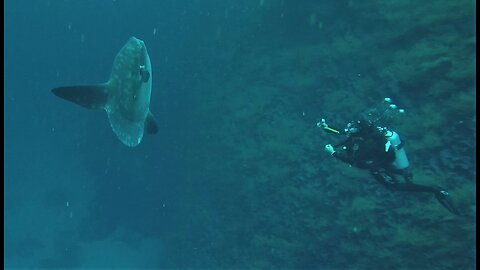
[{"left": 163, "top": 0, "right": 476, "bottom": 269}]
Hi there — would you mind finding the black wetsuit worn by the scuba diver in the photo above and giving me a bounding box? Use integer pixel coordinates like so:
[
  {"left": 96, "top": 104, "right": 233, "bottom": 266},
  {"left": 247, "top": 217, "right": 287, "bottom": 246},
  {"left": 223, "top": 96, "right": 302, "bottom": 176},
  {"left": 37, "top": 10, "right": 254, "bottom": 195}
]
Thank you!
[{"left": 332, "top": 127, "right": 458, "bottom": 214}]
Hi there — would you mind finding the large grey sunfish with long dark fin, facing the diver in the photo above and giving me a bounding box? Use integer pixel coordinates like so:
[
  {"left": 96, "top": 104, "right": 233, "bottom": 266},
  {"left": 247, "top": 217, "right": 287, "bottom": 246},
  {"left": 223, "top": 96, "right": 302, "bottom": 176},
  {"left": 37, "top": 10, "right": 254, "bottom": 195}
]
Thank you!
[{"left": 52, "top": 37, "right": 158, "bottom": 147}]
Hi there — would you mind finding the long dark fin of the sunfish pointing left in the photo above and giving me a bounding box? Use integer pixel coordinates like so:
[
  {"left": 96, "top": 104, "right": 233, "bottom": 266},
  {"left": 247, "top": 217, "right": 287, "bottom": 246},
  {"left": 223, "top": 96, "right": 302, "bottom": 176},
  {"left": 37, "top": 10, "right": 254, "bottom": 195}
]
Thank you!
[{"left": 52, "top": 84, "right": 108, "bottom": 109}]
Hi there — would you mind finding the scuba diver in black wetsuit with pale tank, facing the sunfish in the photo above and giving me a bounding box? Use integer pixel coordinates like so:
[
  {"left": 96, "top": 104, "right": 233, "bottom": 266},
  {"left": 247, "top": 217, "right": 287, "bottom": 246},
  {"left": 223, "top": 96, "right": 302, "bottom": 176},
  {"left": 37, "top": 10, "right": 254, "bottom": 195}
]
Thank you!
[{"left": 317, "top": 98, "right": 459, "bottom": 215}]
